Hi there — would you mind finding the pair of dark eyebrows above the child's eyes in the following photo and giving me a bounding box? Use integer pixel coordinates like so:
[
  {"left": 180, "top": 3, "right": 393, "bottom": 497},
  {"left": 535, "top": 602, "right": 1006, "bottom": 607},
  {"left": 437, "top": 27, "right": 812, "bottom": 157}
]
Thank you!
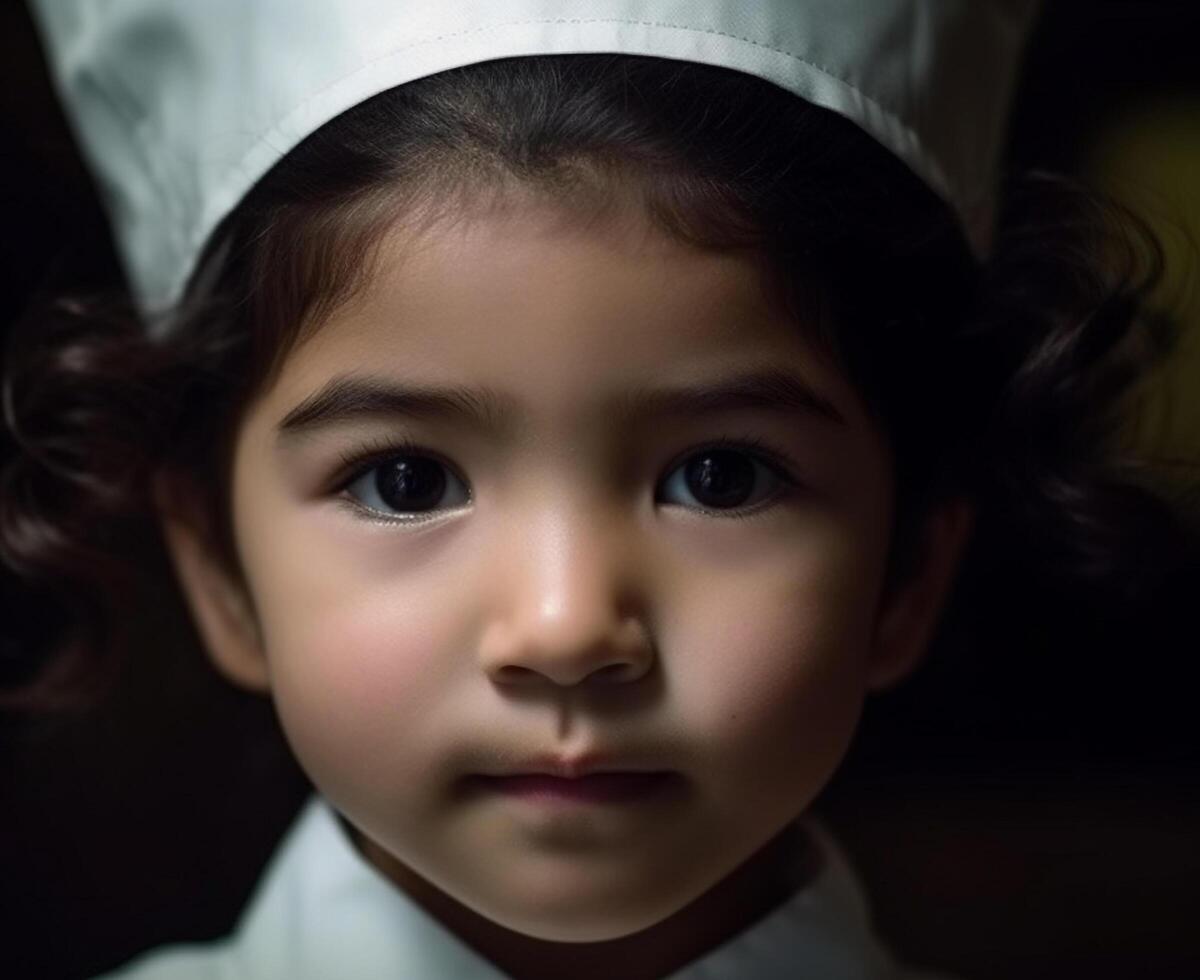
[{"left": 276, "top": 368, "right": 846, "bottom": 443}]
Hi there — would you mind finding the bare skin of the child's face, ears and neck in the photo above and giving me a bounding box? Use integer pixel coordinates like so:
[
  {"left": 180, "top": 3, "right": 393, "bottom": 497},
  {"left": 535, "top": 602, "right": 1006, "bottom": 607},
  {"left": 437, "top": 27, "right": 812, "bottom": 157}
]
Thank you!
[{"left": 161, "top": 187, "right": 971, "bottom": 978}]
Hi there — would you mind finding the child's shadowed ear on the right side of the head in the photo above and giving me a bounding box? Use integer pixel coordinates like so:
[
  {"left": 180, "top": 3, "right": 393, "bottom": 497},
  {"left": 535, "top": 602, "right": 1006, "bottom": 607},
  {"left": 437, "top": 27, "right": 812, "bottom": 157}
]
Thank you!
[{"left": 866, "top": 498, "right": 976, "bottom": 690}]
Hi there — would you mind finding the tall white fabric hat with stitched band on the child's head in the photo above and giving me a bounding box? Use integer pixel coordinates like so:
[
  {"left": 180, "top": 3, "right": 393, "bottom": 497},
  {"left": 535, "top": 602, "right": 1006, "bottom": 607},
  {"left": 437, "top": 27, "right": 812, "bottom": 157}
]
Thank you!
[{"left": 31, "top": 0, "right": 1034, "bottom": 329}]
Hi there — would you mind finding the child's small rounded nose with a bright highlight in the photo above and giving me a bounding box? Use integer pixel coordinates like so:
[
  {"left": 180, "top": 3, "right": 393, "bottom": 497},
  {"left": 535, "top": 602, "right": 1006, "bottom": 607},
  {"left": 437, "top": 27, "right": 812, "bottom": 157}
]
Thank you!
[{"left": 480, "top": 496, "right": 654, "bottom": 687}]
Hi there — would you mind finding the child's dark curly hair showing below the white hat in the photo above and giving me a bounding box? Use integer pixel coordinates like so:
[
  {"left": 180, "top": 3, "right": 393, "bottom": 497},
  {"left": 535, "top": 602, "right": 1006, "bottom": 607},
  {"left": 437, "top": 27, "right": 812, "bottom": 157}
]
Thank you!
[{"left": 0, "top": 55, "right": 1196, "bottom": 708}]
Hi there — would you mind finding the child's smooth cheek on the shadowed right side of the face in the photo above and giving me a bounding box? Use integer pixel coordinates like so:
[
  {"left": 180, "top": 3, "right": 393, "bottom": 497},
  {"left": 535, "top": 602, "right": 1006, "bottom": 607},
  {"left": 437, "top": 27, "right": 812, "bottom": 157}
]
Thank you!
[{"left": 678, "top": 532, "right": 874, "bottom": 801}]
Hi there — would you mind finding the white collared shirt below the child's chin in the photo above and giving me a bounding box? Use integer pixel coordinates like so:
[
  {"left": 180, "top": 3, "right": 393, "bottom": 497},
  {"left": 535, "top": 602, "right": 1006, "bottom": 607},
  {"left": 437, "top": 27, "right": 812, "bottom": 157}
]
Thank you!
[{"left": 93, "top": 796, "right": 949, "bottom": 980}]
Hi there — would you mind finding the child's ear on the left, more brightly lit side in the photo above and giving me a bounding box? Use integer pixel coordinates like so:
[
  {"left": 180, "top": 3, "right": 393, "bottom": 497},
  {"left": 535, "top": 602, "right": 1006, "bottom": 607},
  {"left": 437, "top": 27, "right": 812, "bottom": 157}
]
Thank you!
[{"left": 154, "top": 473, "right": 270, "bottom": 692}]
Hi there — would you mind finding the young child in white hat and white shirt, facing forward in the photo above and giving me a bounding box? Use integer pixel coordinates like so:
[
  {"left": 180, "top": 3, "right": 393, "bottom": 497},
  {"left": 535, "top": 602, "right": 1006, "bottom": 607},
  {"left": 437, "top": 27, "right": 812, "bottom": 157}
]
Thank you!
[{"left": 0, "top": 0, "right": 1182, "bottom": 980}]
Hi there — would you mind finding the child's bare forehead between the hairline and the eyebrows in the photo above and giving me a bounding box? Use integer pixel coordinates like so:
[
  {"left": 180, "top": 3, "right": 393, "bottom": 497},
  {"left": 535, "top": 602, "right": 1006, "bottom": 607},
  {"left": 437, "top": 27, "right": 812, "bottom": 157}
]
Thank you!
[{"left": 291, "top": 199, "right": 828, "bottom": 379}]
